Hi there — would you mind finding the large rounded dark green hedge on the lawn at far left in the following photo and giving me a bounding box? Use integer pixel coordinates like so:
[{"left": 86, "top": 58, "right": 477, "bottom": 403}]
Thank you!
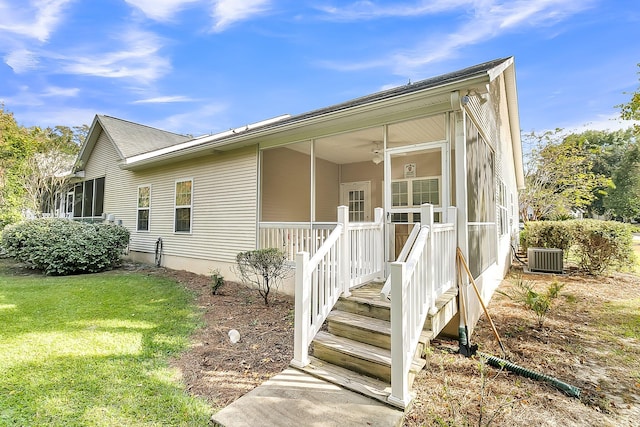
[{"left": 2, "top": 218, "right": 129, "bottom": 275}]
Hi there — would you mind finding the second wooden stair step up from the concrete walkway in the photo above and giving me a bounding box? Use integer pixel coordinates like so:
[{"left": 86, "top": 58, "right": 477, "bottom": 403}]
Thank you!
[{"left": 313, "top": 331, "right": 426, "bottom": 384}]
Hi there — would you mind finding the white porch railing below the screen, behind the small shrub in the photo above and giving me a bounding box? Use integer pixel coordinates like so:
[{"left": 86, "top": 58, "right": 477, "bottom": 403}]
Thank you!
[{"left": 258, "top": 222, "right": 336, "bottom": 262}]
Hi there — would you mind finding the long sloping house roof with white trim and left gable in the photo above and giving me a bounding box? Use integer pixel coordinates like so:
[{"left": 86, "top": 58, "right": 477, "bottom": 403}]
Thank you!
[{"left": 79, "top": 57, "right": 520, "bottom": 181}]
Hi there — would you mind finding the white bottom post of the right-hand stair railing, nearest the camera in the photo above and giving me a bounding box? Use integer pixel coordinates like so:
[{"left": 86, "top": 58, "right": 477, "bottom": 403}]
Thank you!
[{"left": 388, "top": 262, "right": 411, "bottom": 408}]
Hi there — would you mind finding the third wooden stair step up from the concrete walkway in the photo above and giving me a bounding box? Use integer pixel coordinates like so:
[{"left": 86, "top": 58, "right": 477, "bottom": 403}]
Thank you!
[{"left": 327, "top": 310, "right": 391, "bottom": 349}]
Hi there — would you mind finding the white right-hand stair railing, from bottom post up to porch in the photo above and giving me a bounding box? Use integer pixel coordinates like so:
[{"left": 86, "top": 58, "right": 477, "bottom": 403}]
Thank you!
[{"left": 389, "top": 204, "right": 457, "bottom": 406}]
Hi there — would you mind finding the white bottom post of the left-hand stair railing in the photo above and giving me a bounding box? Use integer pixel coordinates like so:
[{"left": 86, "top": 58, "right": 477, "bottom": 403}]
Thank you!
[{"left": 291, "top": 252, "right": 311, "bottom": 368}]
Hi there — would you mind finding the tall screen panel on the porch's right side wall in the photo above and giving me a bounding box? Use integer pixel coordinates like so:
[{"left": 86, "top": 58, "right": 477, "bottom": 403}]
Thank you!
[{"left": 466, "top": 120, "right": 497, "bottom": 277}]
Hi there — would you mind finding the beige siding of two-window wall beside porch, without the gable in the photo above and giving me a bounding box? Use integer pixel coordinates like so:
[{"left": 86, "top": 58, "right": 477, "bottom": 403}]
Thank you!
[{"left": 125, "top": 147, "right": 258, "bottom": 262}]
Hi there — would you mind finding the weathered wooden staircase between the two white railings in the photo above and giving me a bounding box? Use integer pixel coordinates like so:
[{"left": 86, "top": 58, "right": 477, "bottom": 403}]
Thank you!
[{"left": 302, "top": 282, "right": 458, "bottom": 409}]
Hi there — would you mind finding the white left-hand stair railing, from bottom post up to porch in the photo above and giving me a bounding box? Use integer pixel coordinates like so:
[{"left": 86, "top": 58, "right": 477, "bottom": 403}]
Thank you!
[{"left": 291, "top": 206, "right": 384, "bottom": 367}]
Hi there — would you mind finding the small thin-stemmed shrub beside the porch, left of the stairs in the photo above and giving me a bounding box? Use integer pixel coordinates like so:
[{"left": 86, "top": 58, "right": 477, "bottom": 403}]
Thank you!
[{"left": 236, "top": 248, "right": 291, "bottom": 305}]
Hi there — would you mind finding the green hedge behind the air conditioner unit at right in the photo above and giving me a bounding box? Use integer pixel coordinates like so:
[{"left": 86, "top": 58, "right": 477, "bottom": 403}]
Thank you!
[{"left": 520, "top": 219, "right": 634, "bottom": 275}]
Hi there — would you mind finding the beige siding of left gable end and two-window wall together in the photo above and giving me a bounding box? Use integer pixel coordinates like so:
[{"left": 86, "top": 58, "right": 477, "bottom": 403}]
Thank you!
[{"left": 85, "top": 127, "right": 258, "bottom": 262}]
